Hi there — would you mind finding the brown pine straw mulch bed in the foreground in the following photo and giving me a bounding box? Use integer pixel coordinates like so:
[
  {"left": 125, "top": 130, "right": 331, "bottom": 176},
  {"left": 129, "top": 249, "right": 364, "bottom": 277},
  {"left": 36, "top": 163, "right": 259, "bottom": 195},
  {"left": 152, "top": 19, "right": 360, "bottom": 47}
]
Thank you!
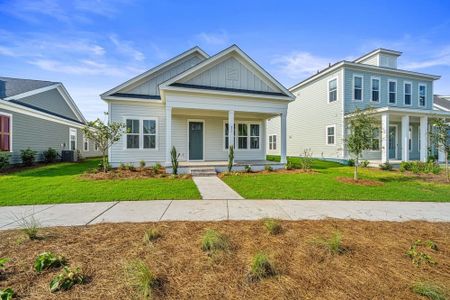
[{"left": 0, "top": 220, "right": 450, "bottom": 299}]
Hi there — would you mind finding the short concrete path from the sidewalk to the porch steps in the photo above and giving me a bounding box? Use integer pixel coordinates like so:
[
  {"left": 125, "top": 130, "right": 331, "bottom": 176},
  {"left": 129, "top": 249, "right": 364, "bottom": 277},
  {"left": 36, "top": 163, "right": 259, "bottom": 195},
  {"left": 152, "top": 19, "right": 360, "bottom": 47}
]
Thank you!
[{"left": 192, "top": 176, "right": 244, "bottom": 200}]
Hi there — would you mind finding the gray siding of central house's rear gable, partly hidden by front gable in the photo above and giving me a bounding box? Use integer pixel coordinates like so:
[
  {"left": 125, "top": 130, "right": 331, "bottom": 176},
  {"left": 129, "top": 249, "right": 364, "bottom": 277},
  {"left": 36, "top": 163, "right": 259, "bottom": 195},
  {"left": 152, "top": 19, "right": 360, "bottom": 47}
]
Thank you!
[{"left": 121, "top": 53, "right": 205, "bottom": 95}]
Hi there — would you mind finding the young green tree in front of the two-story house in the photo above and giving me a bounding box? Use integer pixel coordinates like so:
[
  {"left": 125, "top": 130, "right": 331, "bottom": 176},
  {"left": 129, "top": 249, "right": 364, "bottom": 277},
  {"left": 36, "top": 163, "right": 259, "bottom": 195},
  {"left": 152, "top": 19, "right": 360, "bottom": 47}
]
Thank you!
[{"left": 346, "top": 108, "right": 376, "bottom": 180}]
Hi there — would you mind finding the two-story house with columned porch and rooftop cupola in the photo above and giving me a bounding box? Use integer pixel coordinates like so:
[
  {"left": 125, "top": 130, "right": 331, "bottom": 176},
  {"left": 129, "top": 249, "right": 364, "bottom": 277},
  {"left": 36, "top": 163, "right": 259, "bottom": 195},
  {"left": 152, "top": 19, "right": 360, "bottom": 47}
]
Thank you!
[{"left": 267, "top": 49, "right": 450, "bottom": 162}]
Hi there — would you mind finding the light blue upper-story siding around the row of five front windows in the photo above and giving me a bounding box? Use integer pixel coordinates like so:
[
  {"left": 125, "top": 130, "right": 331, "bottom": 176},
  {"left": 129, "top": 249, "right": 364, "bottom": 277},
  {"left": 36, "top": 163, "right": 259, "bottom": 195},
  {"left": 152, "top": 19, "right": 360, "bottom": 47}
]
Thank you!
[{"left": 344, "top": 67, "right": 433, "bottom": 114}]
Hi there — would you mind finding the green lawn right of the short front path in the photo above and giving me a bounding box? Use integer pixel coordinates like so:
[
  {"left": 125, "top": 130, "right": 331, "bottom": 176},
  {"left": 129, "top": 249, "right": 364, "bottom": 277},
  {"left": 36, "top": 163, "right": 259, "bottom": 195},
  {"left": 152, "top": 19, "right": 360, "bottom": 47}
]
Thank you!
[{"left": 223, "top": 158, "right": 450, "bottom": 202}]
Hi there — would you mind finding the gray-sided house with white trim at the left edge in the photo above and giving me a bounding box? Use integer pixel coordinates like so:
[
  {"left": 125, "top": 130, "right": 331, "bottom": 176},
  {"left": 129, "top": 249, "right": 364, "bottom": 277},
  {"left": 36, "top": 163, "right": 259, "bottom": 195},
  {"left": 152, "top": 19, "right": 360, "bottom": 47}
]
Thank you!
[{"left": 0, "top": 77, "right": 100, "bottom": 163}]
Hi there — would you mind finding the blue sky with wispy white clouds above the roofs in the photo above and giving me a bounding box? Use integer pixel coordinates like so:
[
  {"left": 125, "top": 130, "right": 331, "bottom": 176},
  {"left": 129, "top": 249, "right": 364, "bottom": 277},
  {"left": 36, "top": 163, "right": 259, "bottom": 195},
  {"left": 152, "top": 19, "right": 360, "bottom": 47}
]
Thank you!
[{"left": 0, "top": 0, "right": 450, "bottom": 119}]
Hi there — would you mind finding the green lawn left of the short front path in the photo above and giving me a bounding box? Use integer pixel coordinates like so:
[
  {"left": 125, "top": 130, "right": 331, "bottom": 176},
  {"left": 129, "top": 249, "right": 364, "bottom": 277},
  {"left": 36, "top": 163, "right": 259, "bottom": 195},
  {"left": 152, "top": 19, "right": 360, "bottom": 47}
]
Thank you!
[{"left": 0, "top": 159, "right": 200, "bottom": 206}]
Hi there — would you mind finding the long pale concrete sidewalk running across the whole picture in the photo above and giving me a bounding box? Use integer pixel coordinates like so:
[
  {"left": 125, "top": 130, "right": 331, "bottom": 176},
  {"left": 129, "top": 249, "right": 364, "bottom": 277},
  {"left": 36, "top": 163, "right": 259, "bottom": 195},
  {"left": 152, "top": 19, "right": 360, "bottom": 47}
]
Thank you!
[{"left": 0, "top": 200, "right": 450, "bottom": 230}]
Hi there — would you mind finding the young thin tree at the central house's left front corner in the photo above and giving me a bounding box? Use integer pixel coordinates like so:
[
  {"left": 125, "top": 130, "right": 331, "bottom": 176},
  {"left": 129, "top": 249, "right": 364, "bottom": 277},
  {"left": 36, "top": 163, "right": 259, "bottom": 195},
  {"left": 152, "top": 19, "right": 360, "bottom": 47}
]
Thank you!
[{"left": 82, "top": 113, "right": 125, "bottom": 173}]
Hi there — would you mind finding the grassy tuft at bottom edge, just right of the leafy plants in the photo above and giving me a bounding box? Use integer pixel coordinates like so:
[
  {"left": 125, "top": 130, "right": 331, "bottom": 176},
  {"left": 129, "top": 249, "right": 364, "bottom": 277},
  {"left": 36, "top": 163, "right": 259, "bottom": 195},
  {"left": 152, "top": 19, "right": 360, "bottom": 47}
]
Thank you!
[{"left": 125, "top": 260, "right": 158, "bottom": 299}]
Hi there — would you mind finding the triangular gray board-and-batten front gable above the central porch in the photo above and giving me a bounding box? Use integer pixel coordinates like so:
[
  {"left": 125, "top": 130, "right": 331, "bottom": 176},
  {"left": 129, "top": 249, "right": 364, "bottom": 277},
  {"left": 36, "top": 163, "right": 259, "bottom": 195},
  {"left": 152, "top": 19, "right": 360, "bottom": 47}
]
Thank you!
[{"left": 180, "top": 57, "right": 278, "bottom": 92}]
